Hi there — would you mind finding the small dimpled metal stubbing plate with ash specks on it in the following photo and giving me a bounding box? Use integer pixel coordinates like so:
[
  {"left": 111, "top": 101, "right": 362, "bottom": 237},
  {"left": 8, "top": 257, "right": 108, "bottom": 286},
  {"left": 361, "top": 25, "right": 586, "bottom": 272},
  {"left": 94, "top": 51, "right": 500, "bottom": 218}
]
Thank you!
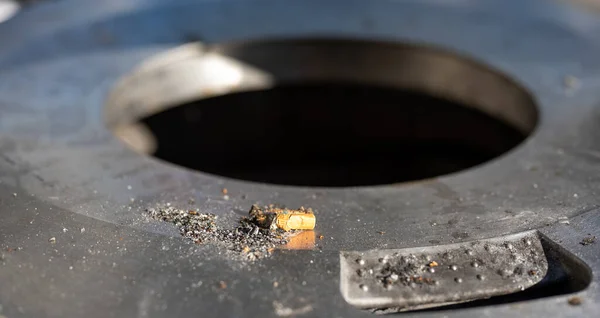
[{"left": 340, "top": 233, "right": 548, "bottom": 310}]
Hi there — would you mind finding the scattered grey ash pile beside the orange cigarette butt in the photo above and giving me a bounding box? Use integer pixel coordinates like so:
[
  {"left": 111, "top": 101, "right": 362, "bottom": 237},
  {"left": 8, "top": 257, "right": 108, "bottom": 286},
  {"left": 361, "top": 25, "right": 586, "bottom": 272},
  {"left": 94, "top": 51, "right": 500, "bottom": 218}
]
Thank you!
[{"left": 146, "top": 206, "right": 293, "bottom": 261}]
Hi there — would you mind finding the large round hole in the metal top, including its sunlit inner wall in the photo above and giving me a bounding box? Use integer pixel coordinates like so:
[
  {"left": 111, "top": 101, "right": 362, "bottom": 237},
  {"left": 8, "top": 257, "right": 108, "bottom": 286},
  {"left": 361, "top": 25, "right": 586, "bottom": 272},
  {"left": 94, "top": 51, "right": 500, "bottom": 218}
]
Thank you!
[{"left": 105, "top": 39, "right": 537, "bottom": 187}]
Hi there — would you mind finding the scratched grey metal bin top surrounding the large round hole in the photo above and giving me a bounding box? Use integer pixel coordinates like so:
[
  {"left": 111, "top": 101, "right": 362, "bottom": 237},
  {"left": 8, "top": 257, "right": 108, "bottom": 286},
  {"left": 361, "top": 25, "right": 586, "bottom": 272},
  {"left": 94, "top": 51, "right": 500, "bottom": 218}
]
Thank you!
[{"left": 0, "top": 0, "right": 600, "bottom": 317}]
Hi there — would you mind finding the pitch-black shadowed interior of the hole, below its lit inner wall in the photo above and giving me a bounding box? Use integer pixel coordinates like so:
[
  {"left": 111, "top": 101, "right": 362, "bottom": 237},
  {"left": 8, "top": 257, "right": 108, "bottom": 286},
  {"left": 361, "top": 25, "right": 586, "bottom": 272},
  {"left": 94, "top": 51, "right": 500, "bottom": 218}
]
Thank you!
[{"left": 142, "top": 84, "right": 525, "bottom": 186}]
